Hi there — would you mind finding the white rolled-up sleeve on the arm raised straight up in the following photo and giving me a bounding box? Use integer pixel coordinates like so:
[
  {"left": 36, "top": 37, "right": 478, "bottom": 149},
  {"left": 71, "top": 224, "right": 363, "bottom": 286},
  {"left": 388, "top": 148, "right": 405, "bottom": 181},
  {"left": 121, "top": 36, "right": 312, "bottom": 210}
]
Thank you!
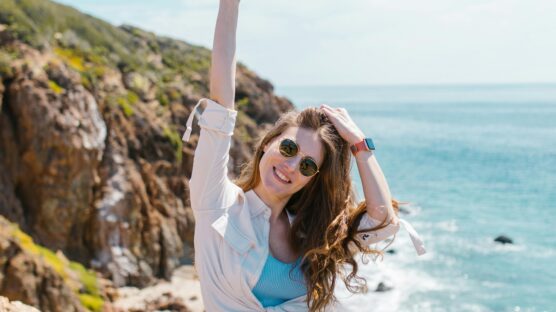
[{"left": 184, "top": 99, "right": 238, "bottom": 211}]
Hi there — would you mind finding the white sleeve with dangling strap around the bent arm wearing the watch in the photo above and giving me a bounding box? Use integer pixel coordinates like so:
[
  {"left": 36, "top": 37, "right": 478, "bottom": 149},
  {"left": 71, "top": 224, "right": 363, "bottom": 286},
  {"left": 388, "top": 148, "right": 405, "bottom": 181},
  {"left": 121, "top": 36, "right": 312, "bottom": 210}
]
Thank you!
[{"left": 356, "top": 213, "right": 426, "bottom": 256}]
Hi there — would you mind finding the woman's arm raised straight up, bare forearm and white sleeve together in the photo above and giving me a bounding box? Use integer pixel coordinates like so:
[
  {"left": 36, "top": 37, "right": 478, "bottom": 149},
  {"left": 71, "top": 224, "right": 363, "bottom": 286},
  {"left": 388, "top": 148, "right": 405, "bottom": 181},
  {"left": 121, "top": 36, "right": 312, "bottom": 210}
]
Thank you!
[{"left": 183, "top": 0, "right": 239, "bottom": 212}]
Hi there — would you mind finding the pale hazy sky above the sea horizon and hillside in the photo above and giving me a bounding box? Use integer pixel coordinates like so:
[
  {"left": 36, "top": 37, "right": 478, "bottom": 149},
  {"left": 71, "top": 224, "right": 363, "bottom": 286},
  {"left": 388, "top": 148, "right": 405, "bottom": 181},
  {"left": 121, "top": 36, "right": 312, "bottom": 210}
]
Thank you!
[{"left": 53, "top": 0, "right": 556, "bottom": 86}]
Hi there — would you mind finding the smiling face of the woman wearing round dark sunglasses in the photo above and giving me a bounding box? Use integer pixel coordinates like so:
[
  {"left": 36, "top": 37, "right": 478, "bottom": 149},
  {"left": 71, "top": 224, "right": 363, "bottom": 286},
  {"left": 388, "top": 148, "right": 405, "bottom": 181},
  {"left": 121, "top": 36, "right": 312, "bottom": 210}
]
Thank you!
[{"left": 259, "top": 127, "right": 324, "bottom": 198}]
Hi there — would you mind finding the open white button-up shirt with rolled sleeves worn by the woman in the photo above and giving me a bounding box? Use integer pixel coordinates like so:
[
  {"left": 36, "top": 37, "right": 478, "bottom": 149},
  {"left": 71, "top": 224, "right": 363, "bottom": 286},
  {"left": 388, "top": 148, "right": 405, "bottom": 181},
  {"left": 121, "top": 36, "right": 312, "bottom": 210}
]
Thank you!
[{"left": 183, "top": 99, "right": 425, "bottom": 312}]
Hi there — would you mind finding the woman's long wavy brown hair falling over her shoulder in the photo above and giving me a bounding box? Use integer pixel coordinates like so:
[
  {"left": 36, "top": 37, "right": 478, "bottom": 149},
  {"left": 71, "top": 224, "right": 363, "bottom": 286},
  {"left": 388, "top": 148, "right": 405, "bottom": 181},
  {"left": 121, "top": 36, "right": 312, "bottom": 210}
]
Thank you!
[{"left": 235, "top": 107, "right": 399, "bottom": 312}]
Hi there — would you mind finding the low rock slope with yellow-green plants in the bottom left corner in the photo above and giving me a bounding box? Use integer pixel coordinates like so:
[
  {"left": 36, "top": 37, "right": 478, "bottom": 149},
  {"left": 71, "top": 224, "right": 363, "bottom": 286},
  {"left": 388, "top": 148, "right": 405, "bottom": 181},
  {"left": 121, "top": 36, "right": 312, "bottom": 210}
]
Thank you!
[{"left": 0, "top": 216, "right": 118, "bottom": 312}]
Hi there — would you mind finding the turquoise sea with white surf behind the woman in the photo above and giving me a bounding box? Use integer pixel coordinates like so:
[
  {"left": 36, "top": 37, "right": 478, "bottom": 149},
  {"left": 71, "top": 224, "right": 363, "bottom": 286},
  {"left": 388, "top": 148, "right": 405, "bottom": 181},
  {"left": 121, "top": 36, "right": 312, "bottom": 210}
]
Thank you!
[{"left": 276, "top": 85, "right": 556, "bottom": 311}]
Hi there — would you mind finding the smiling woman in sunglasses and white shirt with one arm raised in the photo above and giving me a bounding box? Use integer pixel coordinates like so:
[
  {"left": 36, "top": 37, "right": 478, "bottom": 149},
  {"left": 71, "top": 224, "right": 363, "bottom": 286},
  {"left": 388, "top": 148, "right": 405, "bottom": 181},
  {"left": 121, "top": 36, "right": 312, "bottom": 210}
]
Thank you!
[{"left": 183, "top": 0, "right": 425, "bottom": 312}]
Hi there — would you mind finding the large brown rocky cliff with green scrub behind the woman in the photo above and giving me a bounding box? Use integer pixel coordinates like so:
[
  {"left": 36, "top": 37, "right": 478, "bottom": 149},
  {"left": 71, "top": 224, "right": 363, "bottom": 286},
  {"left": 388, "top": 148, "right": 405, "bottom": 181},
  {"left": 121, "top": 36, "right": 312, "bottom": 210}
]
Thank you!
[{"left": 0, "top": 0, "right": 293, "bottom": 310}]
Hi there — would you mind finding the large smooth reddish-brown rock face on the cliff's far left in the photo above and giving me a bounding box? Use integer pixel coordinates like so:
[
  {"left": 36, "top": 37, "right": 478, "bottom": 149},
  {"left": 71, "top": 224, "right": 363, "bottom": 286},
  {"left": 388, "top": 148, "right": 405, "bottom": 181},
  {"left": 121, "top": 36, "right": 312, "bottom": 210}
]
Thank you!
[{"left": 7, "top": 70, "right": 106, "bottom": 260}]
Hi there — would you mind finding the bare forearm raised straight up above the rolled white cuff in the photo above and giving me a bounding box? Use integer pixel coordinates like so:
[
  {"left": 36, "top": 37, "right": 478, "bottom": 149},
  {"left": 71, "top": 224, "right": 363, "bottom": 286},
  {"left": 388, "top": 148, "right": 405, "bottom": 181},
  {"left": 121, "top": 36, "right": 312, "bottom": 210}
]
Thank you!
[{"left": 210, "top": 0, "right": 239, "bottom": 109}]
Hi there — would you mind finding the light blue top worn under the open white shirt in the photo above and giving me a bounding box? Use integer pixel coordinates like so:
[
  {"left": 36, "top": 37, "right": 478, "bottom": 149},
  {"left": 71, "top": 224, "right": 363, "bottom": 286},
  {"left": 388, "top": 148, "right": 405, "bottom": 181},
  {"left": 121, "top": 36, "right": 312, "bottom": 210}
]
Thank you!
[{"left": 252, "top": 252, "right": 307, "bottom": 308}]
